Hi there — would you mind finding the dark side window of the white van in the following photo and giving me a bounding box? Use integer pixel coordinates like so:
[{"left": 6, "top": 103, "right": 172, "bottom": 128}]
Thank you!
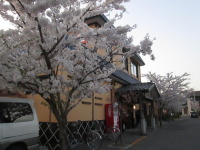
[{"left": 0, "top": 102, "right": 33, "bottom": 123}]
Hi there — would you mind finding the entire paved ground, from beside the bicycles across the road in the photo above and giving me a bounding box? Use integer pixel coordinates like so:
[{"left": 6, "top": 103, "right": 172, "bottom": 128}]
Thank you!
[{"left": 71, "top": 117, "right": 200, "bottom": 150}]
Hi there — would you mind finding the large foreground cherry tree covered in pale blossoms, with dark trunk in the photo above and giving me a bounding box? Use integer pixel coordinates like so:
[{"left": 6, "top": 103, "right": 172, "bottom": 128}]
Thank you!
[{"left": 0, "top": 0, "right": 154, "bottom": 150}]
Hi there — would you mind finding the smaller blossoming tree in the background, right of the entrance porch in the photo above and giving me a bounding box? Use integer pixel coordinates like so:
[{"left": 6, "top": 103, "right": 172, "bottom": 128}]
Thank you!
[{"left": 144, "top": 72, "right": 192, "bottom": 125}]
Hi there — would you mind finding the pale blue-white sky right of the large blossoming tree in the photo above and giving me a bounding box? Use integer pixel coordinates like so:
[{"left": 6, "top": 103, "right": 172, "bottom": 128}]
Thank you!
[{"left": 113, "top": 0, "right": 200, "bottom": 91}]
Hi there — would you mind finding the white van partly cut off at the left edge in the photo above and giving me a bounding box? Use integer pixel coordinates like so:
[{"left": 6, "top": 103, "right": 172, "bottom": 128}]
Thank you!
[{"left": 0, "top": 97, "right": 39, "bottom": 150}]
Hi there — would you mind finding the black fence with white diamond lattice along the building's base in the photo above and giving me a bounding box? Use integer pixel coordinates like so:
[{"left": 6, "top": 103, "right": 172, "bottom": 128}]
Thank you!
[{"left": 39, "top": 120, "right": 105, "bottom": 150}]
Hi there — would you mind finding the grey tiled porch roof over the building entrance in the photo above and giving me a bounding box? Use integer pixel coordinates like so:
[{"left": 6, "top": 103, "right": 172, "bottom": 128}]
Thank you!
[{"left": 116, "top": 82, "right": 160, "bottom": 99}]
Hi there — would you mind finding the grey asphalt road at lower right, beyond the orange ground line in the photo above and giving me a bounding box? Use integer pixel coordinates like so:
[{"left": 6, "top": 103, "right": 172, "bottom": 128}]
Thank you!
[{"left": 128, "top": 118, "right": 200, "bottom": 150}]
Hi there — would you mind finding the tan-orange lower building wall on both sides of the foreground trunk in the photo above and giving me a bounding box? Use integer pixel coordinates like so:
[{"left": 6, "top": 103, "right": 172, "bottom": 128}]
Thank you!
[{"left": 28, "top": 80, "right": 122, "bottom": 122}]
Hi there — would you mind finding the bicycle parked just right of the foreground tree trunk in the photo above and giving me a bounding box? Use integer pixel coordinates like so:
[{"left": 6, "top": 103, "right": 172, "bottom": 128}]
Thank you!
[{"left": 67, "top": 121, "right": 102, "bottom": 150}]
